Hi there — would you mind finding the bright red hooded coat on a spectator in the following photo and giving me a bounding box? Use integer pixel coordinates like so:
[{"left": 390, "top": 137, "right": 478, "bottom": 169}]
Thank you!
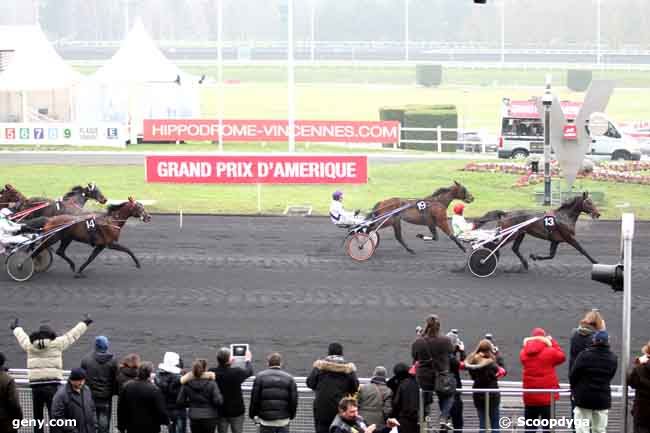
[{"left": 519, "top": 336, "right": 566, "bottom": 406}]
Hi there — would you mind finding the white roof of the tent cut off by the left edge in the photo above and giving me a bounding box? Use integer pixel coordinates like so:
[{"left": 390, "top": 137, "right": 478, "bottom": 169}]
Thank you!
[{"left": 0, "top": 26, "right": 82, "bottom": 91}]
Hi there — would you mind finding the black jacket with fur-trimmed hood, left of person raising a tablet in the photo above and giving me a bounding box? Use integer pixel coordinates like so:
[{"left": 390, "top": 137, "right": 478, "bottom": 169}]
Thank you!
[{"left": 176, "top": 372, "right": 223, "bottom": 419}]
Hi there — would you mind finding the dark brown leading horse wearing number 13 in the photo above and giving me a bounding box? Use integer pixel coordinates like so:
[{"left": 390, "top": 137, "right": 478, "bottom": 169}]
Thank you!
[{"left": 476, "top": 192, "right": 600, "bottom": 270}]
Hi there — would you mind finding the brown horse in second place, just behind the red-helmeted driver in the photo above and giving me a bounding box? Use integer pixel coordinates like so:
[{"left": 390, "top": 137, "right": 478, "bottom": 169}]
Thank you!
[{"left": 366, "top": 181, "right": 474, "bottom": 254}]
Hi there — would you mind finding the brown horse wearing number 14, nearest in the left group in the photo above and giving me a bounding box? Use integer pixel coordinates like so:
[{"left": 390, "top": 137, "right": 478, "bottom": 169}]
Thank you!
[{"left": 34, "top": 197, "right": 151, "bottom": 278}]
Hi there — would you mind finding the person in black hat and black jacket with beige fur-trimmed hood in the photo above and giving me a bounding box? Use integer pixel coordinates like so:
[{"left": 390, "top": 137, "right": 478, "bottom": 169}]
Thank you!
[{"left": 307, "top": 343, "right": 359, "bottom": 433}]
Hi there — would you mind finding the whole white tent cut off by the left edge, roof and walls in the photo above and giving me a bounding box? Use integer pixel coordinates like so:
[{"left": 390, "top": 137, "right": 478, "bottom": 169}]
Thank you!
[{"left": 0, "top": 26, "right": 82, "bottom": 122}]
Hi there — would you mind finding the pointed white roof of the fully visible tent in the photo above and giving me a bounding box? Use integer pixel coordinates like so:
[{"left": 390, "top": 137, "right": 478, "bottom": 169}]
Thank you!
[{"left": 93, "top": 19, "right": 191, "bottom": 84}]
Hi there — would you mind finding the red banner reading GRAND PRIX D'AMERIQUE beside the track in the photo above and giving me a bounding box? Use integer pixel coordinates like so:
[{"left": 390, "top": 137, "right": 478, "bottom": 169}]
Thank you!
[{"left": 145, "top": 155, "right": 368, "bottom": 184}]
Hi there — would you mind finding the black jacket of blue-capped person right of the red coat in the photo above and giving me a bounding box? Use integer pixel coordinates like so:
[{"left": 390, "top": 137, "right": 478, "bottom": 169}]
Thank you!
[{"left": 569, "top": 343, "right": 618, "bottom": 410}]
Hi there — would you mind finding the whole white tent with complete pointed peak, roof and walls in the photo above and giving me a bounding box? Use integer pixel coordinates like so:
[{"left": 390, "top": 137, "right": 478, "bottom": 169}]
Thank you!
[{"left": 79, "top": 20, "right": 200, "bottom": 138}]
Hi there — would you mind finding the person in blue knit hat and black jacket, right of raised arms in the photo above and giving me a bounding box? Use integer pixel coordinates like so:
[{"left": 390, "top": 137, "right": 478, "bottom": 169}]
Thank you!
[{"left": 81, "top": 335, "right": 117, "bottom": 433}]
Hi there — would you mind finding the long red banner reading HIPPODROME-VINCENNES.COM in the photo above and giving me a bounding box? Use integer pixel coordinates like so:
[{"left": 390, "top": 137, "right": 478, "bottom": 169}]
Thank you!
[{"left": 144, "top": 119, "right": 399, "bottom": 143}]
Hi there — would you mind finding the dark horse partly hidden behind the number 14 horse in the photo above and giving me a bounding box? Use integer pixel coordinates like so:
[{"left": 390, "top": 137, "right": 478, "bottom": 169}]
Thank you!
[{"left": 17, "top": 182, "right": 107, "bottom": 219}]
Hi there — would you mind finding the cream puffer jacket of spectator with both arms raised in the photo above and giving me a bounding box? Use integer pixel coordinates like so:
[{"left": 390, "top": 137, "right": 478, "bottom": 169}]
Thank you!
[{"left": 14, "top": 322, "right": 88, "bottom": 383}]
